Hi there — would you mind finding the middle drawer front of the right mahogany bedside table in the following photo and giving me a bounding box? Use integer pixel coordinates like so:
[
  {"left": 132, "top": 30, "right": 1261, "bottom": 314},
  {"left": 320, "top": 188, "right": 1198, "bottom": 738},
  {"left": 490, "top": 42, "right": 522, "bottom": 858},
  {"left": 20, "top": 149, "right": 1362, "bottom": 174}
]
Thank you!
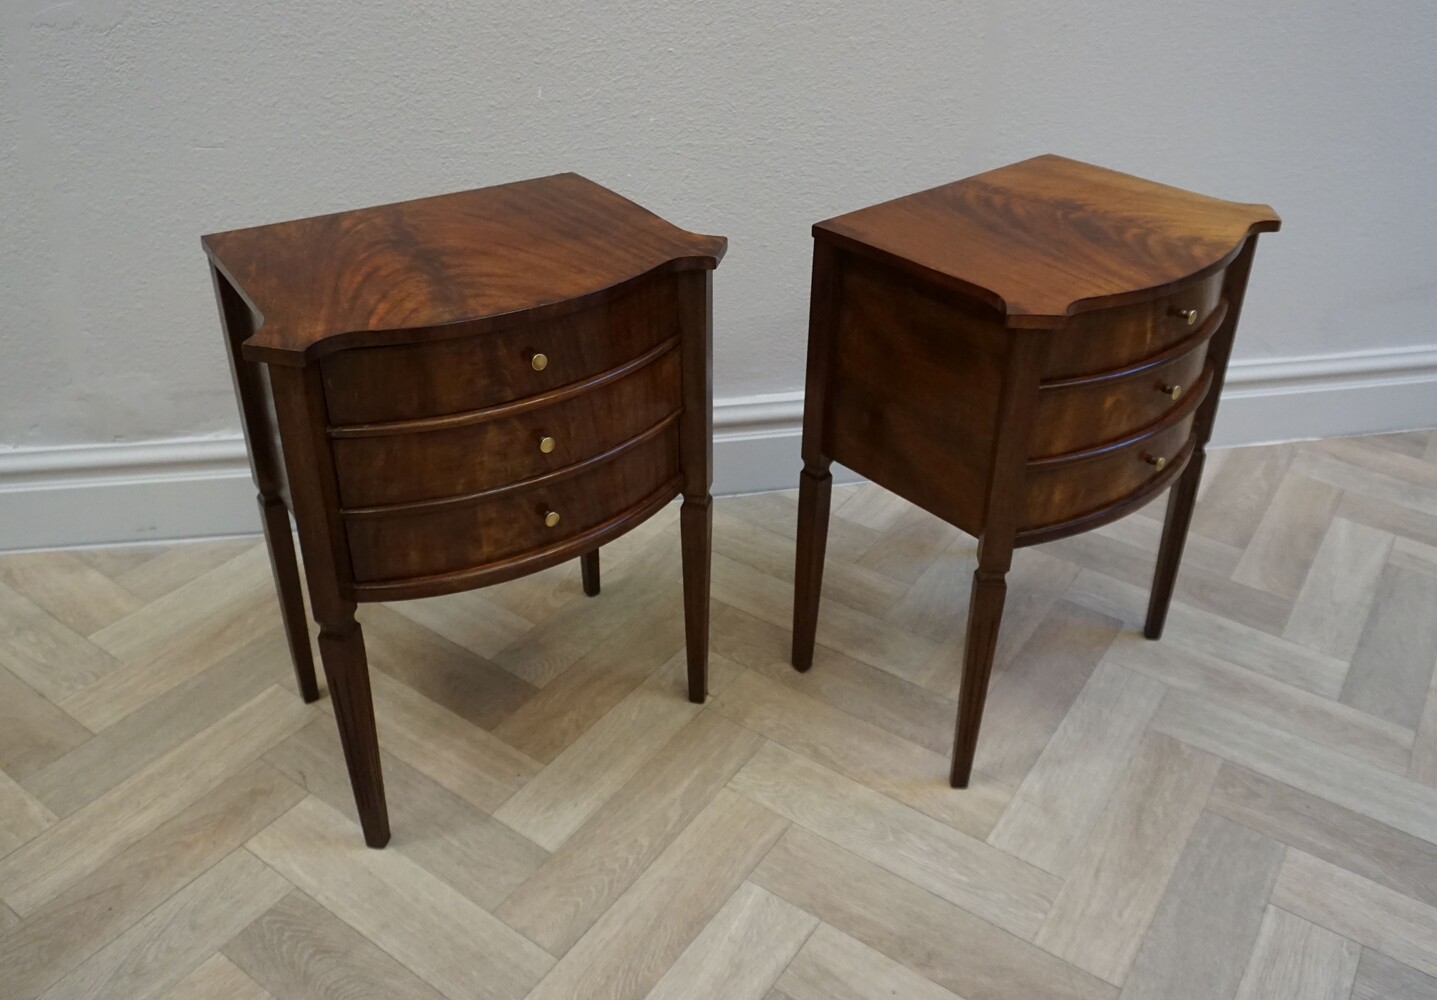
[{"left": 1027, "top": 341, "right": 1211, "bottom": 458}]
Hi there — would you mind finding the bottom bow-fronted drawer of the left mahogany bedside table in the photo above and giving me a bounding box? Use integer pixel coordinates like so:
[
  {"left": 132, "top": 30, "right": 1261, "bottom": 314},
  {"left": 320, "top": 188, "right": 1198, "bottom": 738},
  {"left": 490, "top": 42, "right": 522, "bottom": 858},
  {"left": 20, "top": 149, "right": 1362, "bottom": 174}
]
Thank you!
[{"left": 345, "top": 421, "right": 678, "bottom": 583}]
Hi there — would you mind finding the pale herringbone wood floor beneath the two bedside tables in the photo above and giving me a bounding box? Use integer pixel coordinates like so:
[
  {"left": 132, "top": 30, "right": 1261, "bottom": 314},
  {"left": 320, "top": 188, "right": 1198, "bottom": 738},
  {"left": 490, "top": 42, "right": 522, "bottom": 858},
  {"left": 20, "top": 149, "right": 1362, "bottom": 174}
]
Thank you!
[{"left": 0, "top": 432, "right": 1437, "bottom": 1000}]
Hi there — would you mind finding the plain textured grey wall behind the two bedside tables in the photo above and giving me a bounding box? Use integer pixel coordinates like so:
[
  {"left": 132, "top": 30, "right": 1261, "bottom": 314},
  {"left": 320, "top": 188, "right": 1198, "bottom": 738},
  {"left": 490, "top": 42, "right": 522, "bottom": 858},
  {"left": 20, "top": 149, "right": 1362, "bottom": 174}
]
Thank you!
[{"left": 0, "top": 0, "right": 1437, "bottom": 445}]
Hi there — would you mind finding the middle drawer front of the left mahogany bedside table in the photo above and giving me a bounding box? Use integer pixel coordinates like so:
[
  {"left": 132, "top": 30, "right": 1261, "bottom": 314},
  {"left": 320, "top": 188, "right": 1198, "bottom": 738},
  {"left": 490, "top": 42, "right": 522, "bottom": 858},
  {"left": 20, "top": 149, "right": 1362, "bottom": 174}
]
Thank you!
[{"left": 333, "top": 349, "right": 681, "bottom": 507}]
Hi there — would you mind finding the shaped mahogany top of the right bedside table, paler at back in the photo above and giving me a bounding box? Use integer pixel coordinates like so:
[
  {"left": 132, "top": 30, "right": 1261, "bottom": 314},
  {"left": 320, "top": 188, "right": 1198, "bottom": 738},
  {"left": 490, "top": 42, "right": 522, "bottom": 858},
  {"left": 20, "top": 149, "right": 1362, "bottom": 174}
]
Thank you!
[{"left": 813, "top": 155, "right": 1280, "bottom": 328}]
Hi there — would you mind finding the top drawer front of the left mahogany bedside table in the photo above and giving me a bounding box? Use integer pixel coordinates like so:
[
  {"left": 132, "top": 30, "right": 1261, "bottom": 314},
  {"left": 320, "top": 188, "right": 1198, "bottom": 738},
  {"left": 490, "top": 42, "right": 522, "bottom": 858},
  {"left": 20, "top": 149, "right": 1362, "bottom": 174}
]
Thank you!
[{"left": 320, "top": 276, "right": 678, "bottom": 425}]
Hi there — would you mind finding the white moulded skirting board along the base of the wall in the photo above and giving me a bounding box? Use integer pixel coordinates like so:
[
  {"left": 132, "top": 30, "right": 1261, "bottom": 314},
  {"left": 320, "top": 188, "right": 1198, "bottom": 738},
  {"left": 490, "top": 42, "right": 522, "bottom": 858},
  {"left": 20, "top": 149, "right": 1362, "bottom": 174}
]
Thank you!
[{"left": 0, "top": 346, "right": 1437, "bottom": 550}]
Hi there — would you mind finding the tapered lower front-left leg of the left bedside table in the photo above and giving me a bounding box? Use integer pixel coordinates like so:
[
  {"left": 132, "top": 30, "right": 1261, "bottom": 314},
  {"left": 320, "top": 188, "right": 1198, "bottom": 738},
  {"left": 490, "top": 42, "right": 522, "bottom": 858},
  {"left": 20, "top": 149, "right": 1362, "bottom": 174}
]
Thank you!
[{"left": 319, "top": 614, "right": 389, "bottom": 848}]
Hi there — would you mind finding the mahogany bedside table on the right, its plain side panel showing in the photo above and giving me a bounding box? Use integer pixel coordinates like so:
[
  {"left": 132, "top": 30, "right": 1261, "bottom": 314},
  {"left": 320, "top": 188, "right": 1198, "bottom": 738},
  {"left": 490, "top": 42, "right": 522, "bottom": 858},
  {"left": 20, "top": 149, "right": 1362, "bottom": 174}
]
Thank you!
[{"left": 793, "top": 157, "right": 1279, "bottom": 787}]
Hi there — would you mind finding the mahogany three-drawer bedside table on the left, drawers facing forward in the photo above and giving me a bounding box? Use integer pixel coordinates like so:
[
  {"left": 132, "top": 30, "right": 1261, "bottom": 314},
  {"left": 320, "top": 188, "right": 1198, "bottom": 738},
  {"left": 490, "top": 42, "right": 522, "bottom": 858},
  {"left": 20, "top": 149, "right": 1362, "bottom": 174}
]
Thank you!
[{"left": 203, "top": 174, "right": 726, "bottom": 848}]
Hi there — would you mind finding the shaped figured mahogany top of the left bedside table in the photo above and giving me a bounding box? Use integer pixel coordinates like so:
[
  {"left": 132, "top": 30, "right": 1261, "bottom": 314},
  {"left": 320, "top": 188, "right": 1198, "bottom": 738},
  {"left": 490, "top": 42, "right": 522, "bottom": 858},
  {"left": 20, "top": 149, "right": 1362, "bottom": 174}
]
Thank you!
[{"left": 203, "top": 174, "right": 727, "bottom": 365}]
